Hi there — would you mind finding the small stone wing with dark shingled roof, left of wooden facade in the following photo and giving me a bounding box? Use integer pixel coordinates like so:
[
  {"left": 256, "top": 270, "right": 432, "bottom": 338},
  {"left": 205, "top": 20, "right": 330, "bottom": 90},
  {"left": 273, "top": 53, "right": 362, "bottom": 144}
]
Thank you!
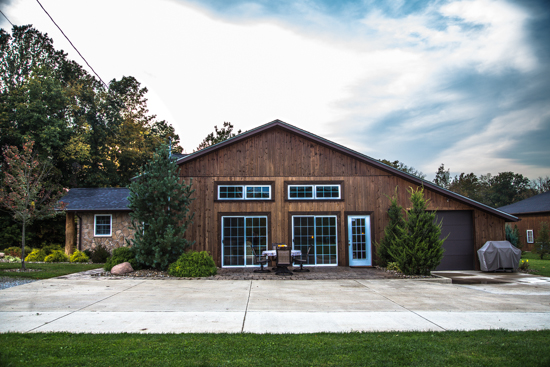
[{"left": 61, "top": 188, "right": 134, "bottom": 253}]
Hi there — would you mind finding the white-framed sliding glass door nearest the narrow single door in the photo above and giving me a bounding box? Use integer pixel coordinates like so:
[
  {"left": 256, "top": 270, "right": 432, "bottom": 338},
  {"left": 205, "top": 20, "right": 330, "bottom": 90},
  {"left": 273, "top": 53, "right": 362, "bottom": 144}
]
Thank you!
[{"left": 292, "top": 215, "right": 338, "bottom": 266}]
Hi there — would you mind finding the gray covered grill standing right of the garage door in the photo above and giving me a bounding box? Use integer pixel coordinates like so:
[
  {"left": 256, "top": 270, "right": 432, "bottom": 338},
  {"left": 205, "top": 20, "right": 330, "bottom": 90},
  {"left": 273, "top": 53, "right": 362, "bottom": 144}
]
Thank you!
[{"left": 477, "top": 241, "right": 521, "bottom": 271}]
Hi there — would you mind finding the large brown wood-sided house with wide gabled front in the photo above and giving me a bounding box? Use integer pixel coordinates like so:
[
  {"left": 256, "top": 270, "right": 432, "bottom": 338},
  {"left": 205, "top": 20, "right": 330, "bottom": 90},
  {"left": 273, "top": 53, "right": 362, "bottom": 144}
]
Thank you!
[{"left": 62, "top": 120, "right": 517, "bottom": 270}]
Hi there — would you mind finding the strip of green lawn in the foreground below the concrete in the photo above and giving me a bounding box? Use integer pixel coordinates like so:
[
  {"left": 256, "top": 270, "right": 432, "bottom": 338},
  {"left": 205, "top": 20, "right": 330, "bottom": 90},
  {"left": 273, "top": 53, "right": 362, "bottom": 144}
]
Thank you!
[{"left": 0, "top": 330, "right": 550, "bottom": 367}]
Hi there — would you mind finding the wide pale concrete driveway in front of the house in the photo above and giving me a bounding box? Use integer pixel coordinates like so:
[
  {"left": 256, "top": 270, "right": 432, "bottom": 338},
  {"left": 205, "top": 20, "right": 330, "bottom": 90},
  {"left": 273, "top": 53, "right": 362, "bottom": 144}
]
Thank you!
[{"left": 0, "top": 277, "right": 550, "bottom": 333}]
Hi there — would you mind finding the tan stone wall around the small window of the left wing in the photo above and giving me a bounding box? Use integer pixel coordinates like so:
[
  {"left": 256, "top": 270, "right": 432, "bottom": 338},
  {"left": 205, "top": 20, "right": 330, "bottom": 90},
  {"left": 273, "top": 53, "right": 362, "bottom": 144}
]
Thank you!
[{"left": 76, "top": 212, "right": 134, "bottom": 252}]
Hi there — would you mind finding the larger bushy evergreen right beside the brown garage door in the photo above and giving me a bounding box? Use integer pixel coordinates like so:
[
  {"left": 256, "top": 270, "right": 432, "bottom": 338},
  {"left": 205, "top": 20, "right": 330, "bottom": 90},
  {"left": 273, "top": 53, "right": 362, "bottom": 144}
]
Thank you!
[{"left": 388, "top": 188, "right": 446, "bottom": 275}]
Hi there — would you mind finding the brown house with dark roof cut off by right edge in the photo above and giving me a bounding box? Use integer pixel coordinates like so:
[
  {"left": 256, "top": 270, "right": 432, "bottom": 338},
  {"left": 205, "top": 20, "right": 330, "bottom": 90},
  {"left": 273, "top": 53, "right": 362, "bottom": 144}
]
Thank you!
[{"left": 498, "top": 191, "right": 550, "bottom": 251}]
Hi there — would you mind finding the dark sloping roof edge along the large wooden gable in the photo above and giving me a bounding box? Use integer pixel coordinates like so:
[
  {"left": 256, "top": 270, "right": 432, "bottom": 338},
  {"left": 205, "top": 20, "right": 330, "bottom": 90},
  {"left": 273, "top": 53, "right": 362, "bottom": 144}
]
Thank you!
[{"left": 176, "top": 120, "right": 518, "bottom": 222}]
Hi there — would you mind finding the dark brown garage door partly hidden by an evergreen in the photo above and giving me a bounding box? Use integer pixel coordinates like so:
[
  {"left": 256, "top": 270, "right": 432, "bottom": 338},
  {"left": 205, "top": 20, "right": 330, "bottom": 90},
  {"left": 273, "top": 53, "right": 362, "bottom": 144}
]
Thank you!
[{"left": 436, "top": 210, "right": 474, "bottom": 270}]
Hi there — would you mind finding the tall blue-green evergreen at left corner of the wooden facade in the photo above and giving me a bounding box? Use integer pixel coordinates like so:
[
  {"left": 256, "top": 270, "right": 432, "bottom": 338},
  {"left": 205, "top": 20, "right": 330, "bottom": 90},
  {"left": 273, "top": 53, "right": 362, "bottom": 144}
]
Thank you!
[{"left": 128, "top": 145, "right": 195, "bottom": 270}]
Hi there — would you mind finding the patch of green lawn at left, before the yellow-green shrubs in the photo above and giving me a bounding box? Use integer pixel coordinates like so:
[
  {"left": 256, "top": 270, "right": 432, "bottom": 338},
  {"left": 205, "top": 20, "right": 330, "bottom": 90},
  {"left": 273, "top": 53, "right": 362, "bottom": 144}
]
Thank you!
[{"left": 0, "top": 263, "right": 103, "bottom": 279}]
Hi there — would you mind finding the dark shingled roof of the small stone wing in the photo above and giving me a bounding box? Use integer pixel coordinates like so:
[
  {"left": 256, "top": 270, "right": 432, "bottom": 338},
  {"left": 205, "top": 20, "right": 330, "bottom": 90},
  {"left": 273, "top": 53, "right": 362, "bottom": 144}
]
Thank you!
[{"left": 59, "top": 187, "right": 130, "bottom": 211}]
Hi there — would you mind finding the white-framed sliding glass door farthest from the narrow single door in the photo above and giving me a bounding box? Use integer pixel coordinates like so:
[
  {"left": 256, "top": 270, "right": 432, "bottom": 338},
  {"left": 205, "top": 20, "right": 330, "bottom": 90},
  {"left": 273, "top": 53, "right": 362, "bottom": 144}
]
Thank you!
[{"left": 222, "top": 216, "right": 268, "bottom": 267}]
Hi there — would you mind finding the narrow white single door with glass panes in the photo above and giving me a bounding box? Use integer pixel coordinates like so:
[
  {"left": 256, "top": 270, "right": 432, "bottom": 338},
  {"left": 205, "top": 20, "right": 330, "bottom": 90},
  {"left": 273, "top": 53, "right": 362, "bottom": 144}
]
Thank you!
[{"left": 348, "top": 215, "right": 372, "bottom": 266}]
